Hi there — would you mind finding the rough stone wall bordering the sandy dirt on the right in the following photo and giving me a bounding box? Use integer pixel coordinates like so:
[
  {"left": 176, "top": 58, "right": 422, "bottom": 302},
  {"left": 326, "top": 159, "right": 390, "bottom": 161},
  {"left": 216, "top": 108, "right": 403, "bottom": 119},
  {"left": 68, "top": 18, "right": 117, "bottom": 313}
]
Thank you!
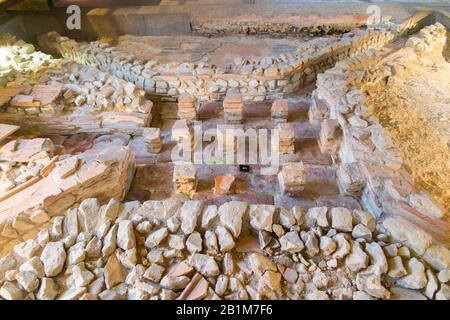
[{"left": 310, "top": 24, "right": 450, "bottom": 245}]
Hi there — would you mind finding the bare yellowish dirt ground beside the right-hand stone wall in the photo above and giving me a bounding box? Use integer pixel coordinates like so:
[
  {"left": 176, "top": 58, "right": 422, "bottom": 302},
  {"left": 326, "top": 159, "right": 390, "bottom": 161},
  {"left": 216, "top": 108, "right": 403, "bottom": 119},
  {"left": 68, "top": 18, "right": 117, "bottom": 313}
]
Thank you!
[{"left": 371, "top": 52, "right": 450, "bottom": 219}]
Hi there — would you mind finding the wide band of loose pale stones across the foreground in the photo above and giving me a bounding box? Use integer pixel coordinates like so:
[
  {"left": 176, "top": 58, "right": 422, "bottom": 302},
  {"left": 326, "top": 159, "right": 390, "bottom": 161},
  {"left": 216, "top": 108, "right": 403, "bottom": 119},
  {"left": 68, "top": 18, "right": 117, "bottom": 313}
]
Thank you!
[{"left": 0, "top": 198, "right": 450, "bottom": 300}]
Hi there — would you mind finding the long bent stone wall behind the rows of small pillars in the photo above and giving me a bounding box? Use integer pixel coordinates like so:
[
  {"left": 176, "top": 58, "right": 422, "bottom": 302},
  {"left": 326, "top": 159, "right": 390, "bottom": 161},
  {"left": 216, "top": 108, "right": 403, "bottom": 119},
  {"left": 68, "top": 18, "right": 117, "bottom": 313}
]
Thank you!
[{"left": 39, "top": 21, "right": 414, "bottom": 101}]
